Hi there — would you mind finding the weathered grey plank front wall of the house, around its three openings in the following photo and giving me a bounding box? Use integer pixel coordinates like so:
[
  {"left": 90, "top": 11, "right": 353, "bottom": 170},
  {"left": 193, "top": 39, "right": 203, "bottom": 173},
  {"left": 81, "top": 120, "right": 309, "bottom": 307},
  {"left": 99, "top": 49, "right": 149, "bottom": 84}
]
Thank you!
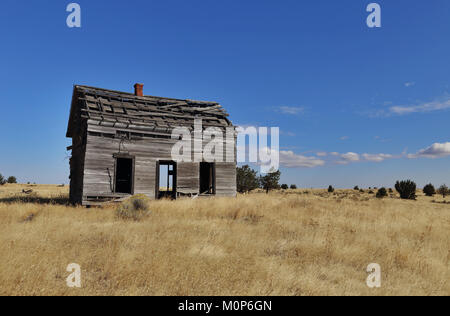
[{"left": 82, "top": 125, "right": 236, "bottom": 198}]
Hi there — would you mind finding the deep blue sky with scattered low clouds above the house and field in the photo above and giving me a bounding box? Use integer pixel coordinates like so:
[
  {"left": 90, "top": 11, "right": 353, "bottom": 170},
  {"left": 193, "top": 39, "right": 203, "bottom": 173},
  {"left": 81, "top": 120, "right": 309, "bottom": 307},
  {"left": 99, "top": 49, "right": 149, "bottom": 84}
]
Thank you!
[{"left": 0, "top": 0, "right": 450, "bottom": 187}]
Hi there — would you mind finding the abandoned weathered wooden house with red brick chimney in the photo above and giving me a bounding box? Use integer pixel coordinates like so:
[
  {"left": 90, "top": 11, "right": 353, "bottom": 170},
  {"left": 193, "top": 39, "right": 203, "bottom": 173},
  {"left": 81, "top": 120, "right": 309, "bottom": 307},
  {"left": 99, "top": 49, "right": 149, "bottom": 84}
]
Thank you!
[{"left": 66, "top": 84, "right": 236, "bottom": 205}]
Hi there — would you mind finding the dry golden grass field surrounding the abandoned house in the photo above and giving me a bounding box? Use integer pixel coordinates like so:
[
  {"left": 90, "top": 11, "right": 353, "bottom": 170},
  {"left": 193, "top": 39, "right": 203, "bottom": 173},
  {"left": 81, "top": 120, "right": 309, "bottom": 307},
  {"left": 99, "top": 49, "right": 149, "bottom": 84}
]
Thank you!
[{"left": 0, "top": 185, "right": 450, "bottom": 295}]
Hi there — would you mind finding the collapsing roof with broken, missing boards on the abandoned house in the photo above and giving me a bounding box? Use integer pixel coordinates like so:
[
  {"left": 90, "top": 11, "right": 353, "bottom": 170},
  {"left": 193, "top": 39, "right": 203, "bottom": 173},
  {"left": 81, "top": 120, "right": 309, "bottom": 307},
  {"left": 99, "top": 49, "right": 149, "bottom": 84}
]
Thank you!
[{"left": 66, "top": 85, "right": 233, "bottom": 137}]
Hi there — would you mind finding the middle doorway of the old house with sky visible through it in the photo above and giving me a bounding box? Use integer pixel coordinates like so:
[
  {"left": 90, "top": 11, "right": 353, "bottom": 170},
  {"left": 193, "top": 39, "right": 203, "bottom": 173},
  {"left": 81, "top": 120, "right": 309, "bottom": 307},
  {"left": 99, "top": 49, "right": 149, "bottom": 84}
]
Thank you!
[{"left": 156, "top": 161, "right": 177, "bottom": 199}]
